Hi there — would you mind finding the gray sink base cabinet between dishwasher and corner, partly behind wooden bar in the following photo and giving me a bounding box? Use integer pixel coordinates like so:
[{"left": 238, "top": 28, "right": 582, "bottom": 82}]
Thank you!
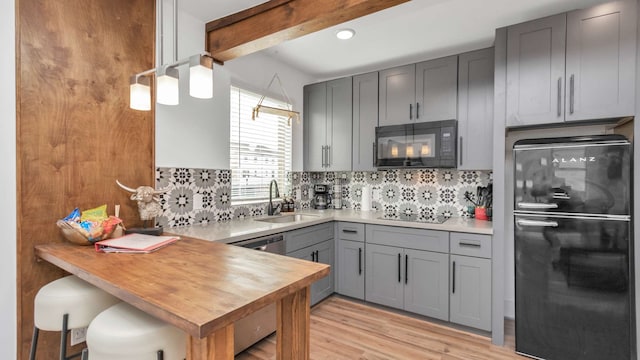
[{"left": 285, "top": 223, "right": 335, "bottom": 305}]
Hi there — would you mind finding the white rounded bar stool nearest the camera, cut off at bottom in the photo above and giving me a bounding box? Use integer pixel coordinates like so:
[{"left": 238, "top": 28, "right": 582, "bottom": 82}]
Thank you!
[{"left": 82, "top": 302, "right": 187, "bottom": 360}]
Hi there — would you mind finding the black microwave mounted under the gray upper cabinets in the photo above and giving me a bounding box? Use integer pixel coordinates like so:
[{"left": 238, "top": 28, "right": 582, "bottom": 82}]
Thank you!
[{"left": 376, "top": 120, "right": 458, "bottom": 168}]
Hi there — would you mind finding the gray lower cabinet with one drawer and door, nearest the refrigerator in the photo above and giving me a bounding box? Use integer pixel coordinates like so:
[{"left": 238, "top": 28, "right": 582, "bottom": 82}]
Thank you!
[{"left": 449, "top": 232, "right": 491, "bottom": 331}]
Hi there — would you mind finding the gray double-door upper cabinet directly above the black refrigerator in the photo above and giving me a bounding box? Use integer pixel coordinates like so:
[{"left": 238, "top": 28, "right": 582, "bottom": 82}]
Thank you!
[{"left": 506, "top": 0, "right": 637, "bottom": 126}]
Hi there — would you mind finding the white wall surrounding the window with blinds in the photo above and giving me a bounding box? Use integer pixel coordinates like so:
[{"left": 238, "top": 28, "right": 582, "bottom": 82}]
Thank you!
[{"left": 156, "top": 1, "right": 314, "bottom": 170}]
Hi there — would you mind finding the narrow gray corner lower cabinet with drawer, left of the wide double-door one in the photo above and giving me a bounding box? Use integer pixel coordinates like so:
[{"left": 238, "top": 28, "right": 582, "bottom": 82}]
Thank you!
[{"left": 336, "top": 222, "right": 365, "bottom": 300}]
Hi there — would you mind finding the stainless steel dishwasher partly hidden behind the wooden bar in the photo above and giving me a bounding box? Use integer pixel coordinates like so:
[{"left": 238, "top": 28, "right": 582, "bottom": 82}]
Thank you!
[{"left": 230, "top": 234, "right": 285, "bottom": 354}]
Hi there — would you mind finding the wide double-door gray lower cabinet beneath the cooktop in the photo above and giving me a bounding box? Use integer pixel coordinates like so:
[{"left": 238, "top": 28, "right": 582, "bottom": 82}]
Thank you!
[{"left": 365, "top": 225, "right": 449, "bottom": 321}]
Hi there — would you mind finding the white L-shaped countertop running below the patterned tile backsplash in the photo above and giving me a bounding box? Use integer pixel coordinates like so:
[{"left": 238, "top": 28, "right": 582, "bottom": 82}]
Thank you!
[{"left": 165, "top": 210, "right": 493, "bottom": 243}]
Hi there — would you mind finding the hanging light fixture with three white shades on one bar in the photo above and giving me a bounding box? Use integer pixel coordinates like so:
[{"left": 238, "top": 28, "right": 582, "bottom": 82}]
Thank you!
[{"left": 129, "top": 0, "right": 213, "bottom": 111}]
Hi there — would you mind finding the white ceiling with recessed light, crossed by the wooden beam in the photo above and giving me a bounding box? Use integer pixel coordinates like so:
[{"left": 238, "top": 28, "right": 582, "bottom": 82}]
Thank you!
[{"left": 180, "top": 0, "right": 606, "bottom": 80}]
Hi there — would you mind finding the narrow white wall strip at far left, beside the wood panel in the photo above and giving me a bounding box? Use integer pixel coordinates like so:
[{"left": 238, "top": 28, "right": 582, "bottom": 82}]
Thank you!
[{"left": 0, "top": 0, "right": 17, "bottom": 359}]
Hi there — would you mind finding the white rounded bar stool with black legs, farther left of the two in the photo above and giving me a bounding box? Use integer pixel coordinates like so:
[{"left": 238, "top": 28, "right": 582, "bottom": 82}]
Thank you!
[{"left": 29, "top": 275, "right": 120, "bottom": 360}]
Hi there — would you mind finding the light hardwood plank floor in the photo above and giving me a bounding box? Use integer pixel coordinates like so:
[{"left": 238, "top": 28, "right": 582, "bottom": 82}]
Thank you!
[{"left": 236, "top": 296, "right": 527, "bottom": 360}]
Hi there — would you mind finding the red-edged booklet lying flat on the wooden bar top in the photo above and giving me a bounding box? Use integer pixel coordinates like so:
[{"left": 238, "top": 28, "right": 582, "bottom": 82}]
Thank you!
[{"left": 94, "top": 234, "right": 180, "bottom": 254}]
